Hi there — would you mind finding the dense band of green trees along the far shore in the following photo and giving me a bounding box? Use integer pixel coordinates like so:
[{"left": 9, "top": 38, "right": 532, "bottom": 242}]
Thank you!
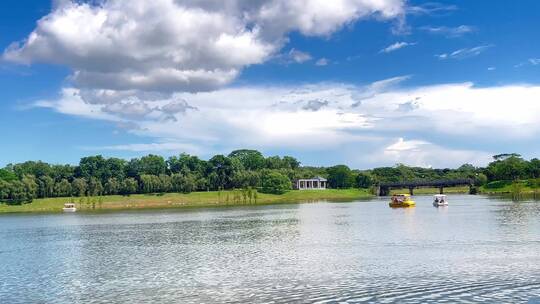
[{"left": 0, "top": 149, "right": 540, "bottom": 204}]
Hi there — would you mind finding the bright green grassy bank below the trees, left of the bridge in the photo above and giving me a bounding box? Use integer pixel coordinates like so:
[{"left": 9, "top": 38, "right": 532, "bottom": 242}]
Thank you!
[{"left": 0, "top": 189, "right": 371, "bottom": 213}]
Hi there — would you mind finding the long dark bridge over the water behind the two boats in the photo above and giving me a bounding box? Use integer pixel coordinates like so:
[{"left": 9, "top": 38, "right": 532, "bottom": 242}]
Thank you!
[{"left": 375, "top": 179, "right": 474, "bottom": 196}]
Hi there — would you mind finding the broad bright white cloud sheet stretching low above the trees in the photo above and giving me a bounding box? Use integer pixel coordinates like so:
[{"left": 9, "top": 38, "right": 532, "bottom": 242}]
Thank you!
[{"left": 36, "top": 76, "right": 540, "bottom": 166}]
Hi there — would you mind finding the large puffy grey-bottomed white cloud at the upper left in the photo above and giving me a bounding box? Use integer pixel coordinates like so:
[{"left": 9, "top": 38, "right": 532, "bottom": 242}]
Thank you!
[{"left": 3, "top": 0, "right": 404, "bottom": 93}]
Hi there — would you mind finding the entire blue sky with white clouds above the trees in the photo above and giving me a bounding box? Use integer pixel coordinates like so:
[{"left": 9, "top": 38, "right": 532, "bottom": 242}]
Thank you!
[{"left": 0, "top": 0, "right": 540, "bottom": 168}]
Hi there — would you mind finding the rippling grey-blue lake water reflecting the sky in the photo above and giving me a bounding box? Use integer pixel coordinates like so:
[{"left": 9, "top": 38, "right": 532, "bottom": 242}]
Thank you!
[{"left": 0, "top": 195, "right": 540, "bottom": 303}]
